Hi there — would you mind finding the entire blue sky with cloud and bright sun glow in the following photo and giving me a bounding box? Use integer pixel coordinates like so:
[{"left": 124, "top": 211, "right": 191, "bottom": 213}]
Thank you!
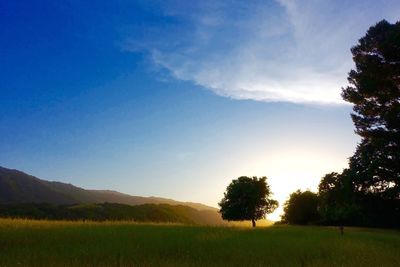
[{"left": 0, "top": 0, "right": 400, "bottom": 220}]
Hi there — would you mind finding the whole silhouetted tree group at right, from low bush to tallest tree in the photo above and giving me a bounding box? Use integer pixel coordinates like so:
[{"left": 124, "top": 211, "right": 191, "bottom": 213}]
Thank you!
[{"left": 283, "top": 21, "right": 400, "bottom": 228}]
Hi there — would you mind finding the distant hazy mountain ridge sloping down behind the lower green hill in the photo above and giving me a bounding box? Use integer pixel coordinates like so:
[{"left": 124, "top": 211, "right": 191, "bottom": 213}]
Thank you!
[{"left": 0, "top": 167, "right": 217, "bottom": 212}]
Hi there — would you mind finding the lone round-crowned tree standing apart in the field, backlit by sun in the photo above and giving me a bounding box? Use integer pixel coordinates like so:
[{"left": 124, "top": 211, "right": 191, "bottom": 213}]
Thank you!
[{"left": 219, "top": 176, "right": 278, "bottom": 227}]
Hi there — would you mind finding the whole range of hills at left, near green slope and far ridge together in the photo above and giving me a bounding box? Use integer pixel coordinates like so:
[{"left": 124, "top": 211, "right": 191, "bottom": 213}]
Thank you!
[{"left": 0, "top": 167, "right": 271, "bottom": 226}]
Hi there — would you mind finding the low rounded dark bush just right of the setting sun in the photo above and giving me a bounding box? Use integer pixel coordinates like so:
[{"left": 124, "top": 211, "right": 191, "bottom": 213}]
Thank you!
[{"left": 282, "top": 190, "right": 319, "bottom": 225}]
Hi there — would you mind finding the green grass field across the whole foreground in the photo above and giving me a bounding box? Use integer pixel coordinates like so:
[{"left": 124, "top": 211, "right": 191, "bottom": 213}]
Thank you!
[{"left": 0, "top": 219, "right": 400, "bottom": 266}]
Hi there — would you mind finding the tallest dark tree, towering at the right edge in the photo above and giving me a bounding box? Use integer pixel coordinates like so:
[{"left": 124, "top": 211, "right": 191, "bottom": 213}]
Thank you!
[{"left": 342, "top": 20, "right": 400, "bottom": 199}]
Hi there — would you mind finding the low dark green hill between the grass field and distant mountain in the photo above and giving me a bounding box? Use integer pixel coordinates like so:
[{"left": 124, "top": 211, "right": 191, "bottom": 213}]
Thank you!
[{"left": 0, "top": 203, "right": 222, "bottom": 224}]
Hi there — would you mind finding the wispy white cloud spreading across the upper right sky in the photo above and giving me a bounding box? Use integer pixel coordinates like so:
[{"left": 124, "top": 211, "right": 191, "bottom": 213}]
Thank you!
[{"left": 123, "top": 0, "right": 400, "bottom": 104}]
